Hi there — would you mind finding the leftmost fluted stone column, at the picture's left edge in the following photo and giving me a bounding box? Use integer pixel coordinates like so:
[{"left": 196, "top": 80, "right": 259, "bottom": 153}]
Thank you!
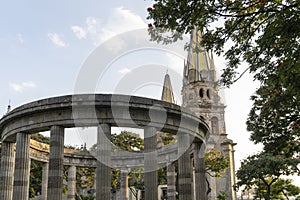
[{"left": 0, "top": 142, "right": 15, "bottom": 200}]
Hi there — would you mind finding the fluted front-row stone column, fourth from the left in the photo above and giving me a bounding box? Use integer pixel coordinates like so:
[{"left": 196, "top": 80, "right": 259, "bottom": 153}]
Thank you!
[{"left": 96, "top": 124, "right": 111, "bottom": 200}]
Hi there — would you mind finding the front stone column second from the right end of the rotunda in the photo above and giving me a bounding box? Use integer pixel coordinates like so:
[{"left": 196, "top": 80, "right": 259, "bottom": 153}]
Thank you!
[{"left": 178, "top": 133, "right": 192, "bottom": 200}]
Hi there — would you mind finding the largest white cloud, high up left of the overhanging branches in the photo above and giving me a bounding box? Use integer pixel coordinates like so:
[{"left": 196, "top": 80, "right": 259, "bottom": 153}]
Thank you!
[{"left": 71, "top": 7, "right": 147, "bottom": 45}]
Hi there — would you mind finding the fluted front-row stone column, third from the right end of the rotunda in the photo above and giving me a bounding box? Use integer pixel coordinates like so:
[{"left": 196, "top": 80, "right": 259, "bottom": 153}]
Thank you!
[{"left": 144, "top": 127, "right": 158, "bottom": 200}]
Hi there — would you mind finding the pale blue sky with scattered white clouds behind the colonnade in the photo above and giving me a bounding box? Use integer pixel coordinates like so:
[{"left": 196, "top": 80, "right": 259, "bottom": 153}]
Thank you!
[{"left": 0, "top": 0, "right": 298, "bottom": 187}]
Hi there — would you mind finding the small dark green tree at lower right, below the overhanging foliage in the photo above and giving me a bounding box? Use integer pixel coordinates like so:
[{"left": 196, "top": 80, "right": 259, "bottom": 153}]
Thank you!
[{"left": 236, "top": 152, "right": 295, "bottom": 200}]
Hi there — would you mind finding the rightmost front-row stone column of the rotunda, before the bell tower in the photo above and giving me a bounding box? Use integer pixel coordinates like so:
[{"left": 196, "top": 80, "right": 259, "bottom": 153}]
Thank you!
[{"left": 193, "top": 142, "right": 207, "bottom": 200}]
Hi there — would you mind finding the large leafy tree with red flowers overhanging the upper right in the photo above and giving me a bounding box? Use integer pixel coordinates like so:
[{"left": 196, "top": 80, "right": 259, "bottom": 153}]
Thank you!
[{"left": 148, "top": 0, "right": 300, "bottom": 158}]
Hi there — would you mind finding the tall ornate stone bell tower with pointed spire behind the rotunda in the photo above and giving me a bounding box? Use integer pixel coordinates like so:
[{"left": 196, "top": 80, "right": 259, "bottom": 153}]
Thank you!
[{"left": 182, "top": 26, "right": 236, "bottom": 200}]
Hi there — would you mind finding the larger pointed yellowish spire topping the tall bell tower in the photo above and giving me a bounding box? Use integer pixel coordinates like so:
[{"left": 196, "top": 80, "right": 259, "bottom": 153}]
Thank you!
[{"left": 184, "top": 26, "right": 215, "bottom": 83}]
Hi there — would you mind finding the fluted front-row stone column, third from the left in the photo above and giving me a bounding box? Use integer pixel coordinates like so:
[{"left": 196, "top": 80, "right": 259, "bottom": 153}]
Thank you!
[{"left": 47, "top": 126, "right": 65, "bottom": 200}]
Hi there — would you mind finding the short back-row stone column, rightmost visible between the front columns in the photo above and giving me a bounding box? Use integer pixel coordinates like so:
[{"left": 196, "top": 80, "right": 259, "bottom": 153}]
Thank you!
[{"left": 167, "top": 162, "right": 176, "bottom": 200}]
